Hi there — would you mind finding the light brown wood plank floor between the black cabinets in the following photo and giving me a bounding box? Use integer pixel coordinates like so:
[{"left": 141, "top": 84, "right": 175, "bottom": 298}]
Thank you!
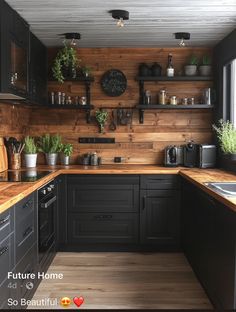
[{"left": 29, "top": 252, "right": 212, "bottom": 309}]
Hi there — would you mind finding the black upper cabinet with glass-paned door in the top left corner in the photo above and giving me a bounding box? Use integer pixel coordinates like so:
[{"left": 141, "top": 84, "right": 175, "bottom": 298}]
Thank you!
[{"left": 0, "top": 1, "right": 29, "bottom": 99}]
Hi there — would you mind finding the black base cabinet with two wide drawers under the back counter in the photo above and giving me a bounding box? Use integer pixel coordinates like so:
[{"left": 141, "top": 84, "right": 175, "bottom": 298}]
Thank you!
[{"left": 67, "top": 175, "right": 139, "bottom": 249}]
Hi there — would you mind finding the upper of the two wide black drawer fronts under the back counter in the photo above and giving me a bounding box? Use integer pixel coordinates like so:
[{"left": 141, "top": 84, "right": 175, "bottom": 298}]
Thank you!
[{"left": 68, "top": 184, "right": 139, "bottom": 213}]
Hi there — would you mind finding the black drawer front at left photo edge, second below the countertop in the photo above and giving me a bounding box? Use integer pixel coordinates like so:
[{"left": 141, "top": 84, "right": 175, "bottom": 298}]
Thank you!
[{"left": 0, "top": 234, "right": 14, "bottom": 284}]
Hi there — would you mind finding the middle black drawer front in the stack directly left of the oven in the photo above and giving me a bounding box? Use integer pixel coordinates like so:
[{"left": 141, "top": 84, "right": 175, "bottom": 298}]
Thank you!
[{"left": 15, "top": 212, "right": 36, "bottom": 263}]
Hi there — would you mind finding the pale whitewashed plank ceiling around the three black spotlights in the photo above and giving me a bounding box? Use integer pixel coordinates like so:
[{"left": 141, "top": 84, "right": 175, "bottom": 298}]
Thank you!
[{"left": 7, "top": 0, "right": 236, "bottom": 47}]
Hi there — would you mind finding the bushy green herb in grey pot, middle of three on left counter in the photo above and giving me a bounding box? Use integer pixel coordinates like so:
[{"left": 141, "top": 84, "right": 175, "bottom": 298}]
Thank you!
[{"left": 39, "top": 134, "right": 61, "bottom": 166}]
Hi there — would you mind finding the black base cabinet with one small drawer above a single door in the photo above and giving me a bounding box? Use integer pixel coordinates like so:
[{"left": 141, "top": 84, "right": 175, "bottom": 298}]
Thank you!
[{"left": 140, "top": 174, "right": 180, "bottom": 249}]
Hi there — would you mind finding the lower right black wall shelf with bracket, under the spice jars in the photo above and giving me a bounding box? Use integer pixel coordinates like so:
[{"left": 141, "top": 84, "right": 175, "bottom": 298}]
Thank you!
[{"left": 136, "top": 104, "right": 213, "bottom": 124}]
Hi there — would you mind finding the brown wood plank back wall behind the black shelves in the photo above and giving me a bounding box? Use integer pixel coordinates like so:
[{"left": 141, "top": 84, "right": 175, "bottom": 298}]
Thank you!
[{"left": 0, "top": 48, "right": 212, "bottom": 164}]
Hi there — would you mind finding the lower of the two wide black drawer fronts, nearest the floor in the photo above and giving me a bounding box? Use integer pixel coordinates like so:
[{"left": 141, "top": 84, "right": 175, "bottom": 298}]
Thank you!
[{"left": 68, "top": 213, "right": 139, "bottom": 244}]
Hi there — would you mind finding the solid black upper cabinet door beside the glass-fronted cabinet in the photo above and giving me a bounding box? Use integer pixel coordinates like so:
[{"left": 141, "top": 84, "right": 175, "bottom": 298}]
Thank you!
[{"left": 29, "top": 33, "right": 47, "bottom": 105}]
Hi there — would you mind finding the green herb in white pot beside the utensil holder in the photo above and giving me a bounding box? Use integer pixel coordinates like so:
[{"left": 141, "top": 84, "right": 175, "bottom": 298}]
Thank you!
[{"left": 24, "top": 136, "right": 38, "bottom": 168}]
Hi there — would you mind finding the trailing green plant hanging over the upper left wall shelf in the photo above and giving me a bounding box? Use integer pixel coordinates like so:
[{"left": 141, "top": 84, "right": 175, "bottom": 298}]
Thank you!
[{"left": 52, "top": 43, "right": 80, "bottom": 83}]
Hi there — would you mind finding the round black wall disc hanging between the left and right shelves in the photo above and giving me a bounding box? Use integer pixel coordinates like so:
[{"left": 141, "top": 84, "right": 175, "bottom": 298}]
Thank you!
[{"left": 101, "top": 69, "right": 127, "bottom": 96}]
